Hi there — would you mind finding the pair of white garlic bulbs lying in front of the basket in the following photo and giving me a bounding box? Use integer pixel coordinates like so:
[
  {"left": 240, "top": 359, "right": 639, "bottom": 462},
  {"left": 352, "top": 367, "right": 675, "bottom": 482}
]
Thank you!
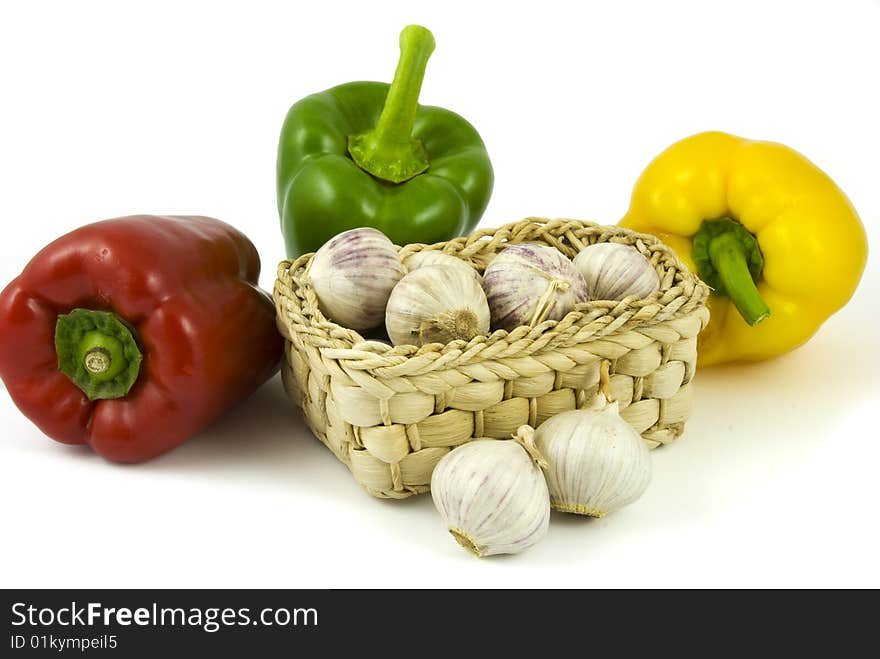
[{"left": 431, "top": 378, "right": 651, "bottom": 556}]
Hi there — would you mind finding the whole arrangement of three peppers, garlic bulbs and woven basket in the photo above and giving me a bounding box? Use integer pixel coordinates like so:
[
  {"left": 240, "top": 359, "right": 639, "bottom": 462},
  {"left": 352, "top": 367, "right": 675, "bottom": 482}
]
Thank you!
[{"left": 0, "top": 25, "right": 867, "bottom": 556}]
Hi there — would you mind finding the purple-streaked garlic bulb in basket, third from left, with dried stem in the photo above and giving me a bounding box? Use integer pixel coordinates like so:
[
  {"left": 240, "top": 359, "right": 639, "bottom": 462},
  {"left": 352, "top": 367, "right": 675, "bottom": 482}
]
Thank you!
[{"left": 483, "top": 244, "right": 589, "bottom": 330}]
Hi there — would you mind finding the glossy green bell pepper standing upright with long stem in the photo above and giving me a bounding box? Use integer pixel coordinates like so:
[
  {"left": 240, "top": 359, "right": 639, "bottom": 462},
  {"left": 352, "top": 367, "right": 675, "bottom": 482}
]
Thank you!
[{"left": 277, "top": 25, "right": 493, "bottom": 258}]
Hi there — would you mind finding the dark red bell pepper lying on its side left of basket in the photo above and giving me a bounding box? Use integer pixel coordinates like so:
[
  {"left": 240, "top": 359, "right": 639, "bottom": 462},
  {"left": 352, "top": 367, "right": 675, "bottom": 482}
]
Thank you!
[{"left": 0, "top": 215, "right": 282, "bottom": 462}]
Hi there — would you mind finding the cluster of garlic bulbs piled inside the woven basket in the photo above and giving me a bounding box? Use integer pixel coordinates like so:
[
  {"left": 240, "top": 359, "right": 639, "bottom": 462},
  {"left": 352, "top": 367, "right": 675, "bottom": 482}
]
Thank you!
[{"left": 308, "top": 227, "right": 660, "bottom": 346}]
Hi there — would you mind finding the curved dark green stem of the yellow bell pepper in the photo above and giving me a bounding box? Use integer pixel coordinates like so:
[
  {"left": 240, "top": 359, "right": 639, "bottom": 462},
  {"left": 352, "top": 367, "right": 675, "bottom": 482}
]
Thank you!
[{"left": 693, "top": 217, "right": 770, "bottom": 325}]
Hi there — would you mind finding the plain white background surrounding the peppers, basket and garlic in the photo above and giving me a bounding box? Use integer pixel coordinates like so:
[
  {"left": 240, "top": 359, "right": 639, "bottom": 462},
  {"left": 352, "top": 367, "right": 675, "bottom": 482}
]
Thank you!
[{"left": 0, "top": 0, "right": 880, "bottom": 587}]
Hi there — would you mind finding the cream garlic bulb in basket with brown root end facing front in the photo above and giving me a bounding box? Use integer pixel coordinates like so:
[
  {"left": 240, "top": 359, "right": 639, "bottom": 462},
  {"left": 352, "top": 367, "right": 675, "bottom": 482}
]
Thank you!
[{"left": 385, "top": 265, "right": 489, "bottom": 346}]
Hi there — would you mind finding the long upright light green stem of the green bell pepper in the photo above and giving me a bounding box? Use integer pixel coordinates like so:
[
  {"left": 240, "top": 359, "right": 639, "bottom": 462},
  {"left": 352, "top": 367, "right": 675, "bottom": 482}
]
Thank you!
[{"left": 348, "top": 25, "right": 434, "bottom": 183}]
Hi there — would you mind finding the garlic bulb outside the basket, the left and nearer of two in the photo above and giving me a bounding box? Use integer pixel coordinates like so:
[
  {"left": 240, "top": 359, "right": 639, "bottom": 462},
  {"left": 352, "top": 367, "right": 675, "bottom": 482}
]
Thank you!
[{"left": 431, "top": 437, "right": 550, "bottom": 556}]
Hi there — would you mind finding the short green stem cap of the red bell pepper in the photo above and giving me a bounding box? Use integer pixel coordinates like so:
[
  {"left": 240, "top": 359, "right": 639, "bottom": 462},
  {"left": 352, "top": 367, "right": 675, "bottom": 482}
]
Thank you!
[{"left": 55, "top": 309, "right": 143, "bottom": 400}]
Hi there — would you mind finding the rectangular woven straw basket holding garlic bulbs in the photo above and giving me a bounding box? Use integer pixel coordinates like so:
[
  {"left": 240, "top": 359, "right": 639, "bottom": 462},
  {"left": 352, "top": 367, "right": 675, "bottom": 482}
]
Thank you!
[{"left": 275, "top": 218, "right": 709, "bottom": 498}]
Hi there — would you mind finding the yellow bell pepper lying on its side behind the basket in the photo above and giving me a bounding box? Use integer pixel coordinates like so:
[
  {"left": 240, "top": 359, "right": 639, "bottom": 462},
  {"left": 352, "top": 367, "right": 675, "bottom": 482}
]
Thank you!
[{"left": 620, "top": 132, "right": 868, "bottom": 366}]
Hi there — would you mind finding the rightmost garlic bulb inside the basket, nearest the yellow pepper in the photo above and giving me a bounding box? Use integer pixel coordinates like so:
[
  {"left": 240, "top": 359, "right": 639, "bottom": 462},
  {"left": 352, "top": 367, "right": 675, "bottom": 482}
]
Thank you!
[{"left": 574, "top": 243, "right": 660, "bottom": 300}]
